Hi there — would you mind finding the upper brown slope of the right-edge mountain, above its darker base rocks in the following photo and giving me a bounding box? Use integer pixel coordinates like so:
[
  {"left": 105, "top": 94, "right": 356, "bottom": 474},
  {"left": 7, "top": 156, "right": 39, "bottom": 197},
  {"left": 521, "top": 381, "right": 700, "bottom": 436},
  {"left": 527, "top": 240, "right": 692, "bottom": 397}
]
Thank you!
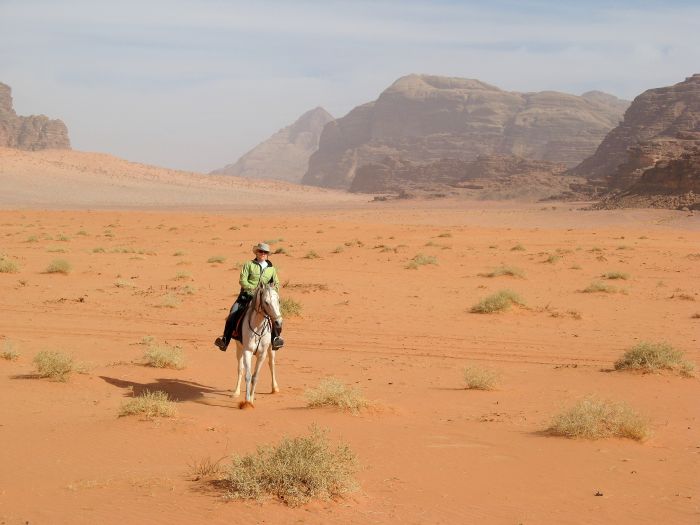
[{"left": 569, "top": 74, "right": 700, "bottom": 190}]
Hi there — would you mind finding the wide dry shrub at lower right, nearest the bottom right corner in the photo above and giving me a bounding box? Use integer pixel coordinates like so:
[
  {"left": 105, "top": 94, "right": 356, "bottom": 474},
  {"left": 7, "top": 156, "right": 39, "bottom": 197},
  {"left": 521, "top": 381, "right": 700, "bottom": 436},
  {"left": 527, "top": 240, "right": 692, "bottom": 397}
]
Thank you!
[{"left": 547, "top": 397, "right": 650, "bottom": 441}]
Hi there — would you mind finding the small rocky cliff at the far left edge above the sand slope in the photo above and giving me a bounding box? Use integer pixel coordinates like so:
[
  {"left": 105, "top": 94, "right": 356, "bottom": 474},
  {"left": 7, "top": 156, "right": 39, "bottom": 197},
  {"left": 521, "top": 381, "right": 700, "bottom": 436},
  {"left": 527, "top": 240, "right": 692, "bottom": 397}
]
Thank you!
[{"left": 0, "top": 82, "right": 70, "bottom": 151}]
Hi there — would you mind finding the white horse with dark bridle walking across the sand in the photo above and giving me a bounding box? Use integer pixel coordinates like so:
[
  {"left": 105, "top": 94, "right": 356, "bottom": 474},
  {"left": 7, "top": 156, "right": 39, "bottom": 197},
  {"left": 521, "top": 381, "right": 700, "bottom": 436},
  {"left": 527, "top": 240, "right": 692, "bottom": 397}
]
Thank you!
[{"left": 233, "top": 284, "right": 282, "bottom": 408}]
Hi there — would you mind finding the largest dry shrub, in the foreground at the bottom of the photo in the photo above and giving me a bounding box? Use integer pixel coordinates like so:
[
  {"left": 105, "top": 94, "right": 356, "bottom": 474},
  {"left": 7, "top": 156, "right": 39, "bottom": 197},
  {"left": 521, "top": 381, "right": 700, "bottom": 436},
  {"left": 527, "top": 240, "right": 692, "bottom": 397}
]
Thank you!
[{"left": 221, "top": 427, "right": 357, "bottom": 507}]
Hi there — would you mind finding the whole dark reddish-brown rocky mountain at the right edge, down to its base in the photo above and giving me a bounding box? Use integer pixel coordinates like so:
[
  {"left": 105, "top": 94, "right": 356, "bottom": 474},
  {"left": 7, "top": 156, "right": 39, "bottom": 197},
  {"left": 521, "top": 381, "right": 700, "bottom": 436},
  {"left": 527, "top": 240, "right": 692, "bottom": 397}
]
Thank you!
[{"left": 569, "top": 74, "right": 700, "bottom": 207}]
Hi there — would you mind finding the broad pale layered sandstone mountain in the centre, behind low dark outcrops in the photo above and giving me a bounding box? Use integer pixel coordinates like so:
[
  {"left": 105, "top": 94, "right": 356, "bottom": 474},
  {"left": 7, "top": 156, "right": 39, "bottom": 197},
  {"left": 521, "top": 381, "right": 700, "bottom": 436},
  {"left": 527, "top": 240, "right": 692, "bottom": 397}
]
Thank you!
[{"left": 302, "top": 75, "right": 627, "bottom": 189}]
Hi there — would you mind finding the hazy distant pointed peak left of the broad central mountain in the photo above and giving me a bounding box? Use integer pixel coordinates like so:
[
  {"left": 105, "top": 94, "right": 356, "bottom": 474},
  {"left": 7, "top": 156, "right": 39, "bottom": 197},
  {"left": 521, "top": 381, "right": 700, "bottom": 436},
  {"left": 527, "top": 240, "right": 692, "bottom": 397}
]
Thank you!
[{"left": 212, "top": 107, "right": 333, "bottom": 183}]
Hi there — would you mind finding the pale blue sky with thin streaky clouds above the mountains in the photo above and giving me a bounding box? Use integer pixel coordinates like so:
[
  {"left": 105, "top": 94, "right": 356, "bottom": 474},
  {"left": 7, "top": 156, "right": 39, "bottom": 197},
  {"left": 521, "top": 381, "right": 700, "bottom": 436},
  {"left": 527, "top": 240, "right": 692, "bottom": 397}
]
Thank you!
[{"left": 0, "top": 0, "right": 700, "bottom": 172}]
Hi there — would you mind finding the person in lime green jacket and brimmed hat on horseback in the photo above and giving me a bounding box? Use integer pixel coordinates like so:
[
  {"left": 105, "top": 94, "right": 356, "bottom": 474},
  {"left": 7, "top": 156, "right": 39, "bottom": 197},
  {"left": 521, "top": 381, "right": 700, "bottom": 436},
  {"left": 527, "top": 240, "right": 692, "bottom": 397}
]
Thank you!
[{"left": 214, "top": 242, "right": 284, "bottom": 352}]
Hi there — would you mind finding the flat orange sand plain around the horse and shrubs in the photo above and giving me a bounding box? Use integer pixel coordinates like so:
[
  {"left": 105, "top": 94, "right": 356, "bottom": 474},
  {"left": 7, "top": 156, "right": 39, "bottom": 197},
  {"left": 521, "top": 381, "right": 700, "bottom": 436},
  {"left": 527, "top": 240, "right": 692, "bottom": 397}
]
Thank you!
[{"left": 0, "top": 202, "right": 700, "bottom": 525}]
